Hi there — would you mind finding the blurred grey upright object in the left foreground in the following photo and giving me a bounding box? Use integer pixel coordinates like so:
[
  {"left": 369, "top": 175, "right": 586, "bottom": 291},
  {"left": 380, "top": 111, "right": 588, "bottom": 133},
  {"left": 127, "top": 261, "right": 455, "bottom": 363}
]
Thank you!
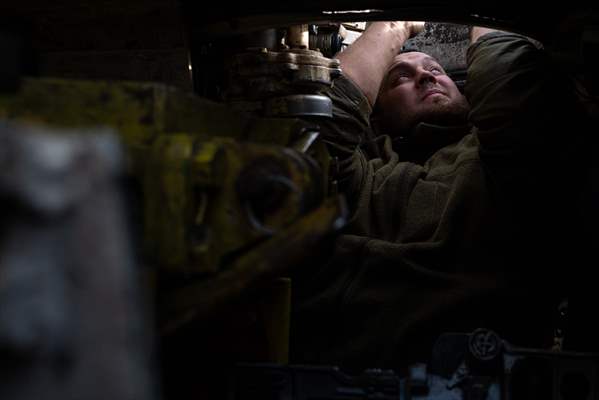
[{"left": 0, "top": 122, "right": 156, "bottom": 400}]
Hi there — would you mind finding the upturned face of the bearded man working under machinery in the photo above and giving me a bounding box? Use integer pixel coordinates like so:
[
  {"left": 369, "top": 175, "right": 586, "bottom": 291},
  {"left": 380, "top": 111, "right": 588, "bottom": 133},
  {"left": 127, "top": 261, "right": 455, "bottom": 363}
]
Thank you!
[{"left": 377, "top": 52, "right": 469, "bottom": 135}]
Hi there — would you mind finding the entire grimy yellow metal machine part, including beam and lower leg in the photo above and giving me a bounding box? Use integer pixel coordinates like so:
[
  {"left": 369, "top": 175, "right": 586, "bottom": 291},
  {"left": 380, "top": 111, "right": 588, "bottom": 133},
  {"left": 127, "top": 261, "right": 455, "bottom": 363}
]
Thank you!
[{"left": 0, "top": 79, "right": 343, "bottom": 362}]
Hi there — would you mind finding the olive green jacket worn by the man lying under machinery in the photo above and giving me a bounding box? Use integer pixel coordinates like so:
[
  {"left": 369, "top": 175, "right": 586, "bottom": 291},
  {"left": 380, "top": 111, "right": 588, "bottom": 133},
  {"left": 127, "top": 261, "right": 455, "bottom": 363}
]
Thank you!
[{"left": 291, "top": 33, "right": 584, "bottom": 370}]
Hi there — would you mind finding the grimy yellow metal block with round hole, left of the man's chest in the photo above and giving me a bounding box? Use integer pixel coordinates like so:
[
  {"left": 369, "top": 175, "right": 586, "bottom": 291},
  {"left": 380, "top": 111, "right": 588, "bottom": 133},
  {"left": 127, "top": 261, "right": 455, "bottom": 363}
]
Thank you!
[{"left": 143, "top": 134, "right": 323, "bottom": 273}]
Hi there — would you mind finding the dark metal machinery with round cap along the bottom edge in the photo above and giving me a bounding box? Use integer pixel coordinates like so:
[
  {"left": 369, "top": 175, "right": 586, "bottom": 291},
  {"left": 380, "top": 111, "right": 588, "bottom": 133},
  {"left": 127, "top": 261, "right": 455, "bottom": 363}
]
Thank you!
[{"left": 229, "top": 329, "right": 599, "bottom": 400}]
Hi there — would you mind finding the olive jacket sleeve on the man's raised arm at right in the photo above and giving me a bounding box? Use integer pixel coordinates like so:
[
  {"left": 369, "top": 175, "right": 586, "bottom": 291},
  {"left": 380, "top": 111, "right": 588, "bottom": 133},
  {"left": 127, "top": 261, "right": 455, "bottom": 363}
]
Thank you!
[{"left": 465, "top": 32, "right": 584, "bottom": 180}]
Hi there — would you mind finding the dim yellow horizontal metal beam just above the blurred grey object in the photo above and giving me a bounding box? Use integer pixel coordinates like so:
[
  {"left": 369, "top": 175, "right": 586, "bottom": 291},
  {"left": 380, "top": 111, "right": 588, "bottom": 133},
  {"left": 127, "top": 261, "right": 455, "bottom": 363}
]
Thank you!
[{"left": 0, "top": 79, "right": 250, "bottom": 151}]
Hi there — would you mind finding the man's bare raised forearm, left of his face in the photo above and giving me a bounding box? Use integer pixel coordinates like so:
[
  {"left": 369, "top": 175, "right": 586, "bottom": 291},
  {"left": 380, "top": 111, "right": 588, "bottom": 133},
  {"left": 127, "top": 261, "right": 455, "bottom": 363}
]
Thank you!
[{"left": 337, "top": 21, "right": 424, "bottom": 105}]
